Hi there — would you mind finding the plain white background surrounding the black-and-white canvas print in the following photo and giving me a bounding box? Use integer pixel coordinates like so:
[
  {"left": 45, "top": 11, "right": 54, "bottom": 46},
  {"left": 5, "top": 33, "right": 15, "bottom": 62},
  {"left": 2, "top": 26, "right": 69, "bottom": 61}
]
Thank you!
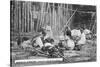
[{"left": 0, "top": 0, "right": 100, "bottom": 67}]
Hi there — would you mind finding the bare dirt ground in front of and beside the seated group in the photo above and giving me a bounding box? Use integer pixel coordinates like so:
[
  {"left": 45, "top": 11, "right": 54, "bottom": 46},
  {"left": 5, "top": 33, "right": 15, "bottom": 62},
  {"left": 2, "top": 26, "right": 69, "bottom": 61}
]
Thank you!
[{"left": 11, "top": 40, "right": 96, "bottom": 67}]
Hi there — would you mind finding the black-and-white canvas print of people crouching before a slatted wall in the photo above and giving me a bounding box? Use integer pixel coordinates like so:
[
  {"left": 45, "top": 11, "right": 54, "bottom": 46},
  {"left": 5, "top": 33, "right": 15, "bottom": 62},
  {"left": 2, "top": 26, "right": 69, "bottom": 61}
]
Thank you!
[{"left": 10, "top": 0, "right": 97, "bottom": 67}]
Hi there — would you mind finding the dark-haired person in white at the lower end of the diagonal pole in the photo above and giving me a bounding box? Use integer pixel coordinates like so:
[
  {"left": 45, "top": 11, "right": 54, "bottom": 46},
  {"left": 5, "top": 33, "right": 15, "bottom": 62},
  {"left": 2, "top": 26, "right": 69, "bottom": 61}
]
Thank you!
[{"left": 58, "top": 27, "right": 75, "bottom": 50}]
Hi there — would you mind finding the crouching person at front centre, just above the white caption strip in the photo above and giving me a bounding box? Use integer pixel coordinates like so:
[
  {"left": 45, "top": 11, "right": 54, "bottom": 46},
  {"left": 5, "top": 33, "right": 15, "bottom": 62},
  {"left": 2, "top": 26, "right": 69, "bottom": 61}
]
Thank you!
[{"left": 42, "top": 38, "right": 60, "bottom": 57}]
